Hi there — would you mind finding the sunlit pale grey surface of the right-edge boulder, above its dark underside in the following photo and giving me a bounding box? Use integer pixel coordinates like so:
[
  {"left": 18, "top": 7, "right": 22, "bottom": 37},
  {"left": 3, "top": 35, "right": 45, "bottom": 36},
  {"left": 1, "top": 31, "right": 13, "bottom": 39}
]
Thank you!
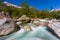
[{"left": 48, "top": 21, "right": 60, "bottom": 38}]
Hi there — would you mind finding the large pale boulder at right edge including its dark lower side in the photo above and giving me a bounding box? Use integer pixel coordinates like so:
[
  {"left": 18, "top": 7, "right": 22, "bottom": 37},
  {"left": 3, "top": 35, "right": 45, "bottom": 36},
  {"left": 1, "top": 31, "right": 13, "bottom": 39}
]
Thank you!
[{"left": 47, "top": 20, "right": 60, "bottom": 39}]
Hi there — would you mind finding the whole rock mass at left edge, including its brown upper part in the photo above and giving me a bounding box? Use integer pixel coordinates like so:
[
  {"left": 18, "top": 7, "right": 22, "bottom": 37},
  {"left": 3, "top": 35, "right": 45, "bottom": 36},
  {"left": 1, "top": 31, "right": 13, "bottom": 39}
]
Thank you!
[{"left": 0, "top": 12, "right": 15, "bottom": 36}]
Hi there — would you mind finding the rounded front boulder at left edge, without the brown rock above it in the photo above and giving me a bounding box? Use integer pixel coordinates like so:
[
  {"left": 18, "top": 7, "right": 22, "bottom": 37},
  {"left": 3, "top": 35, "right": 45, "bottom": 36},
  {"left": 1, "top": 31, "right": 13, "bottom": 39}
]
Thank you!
[{"left": 0, "top": 18, "right": 14, "bottom": 36}]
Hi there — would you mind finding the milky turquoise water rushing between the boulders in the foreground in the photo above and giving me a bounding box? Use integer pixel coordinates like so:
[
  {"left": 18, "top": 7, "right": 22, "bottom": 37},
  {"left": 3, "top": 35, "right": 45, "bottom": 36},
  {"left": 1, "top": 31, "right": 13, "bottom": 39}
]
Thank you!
[{"left": 0, "top": 25, "right": 59, "bottom": 40}]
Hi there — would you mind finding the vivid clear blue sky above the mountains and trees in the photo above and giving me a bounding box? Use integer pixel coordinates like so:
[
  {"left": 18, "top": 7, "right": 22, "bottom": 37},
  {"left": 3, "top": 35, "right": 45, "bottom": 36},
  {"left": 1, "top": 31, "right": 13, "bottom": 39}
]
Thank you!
[{"left": 5, "top": 0, "right": 60, "bottom": 10}]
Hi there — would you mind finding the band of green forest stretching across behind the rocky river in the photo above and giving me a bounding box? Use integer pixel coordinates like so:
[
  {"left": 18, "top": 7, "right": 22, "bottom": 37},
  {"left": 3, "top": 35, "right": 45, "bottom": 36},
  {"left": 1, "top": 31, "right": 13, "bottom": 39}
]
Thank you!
[{"left": 0, "top": 1, "right": 60, "bottom": 19}]
